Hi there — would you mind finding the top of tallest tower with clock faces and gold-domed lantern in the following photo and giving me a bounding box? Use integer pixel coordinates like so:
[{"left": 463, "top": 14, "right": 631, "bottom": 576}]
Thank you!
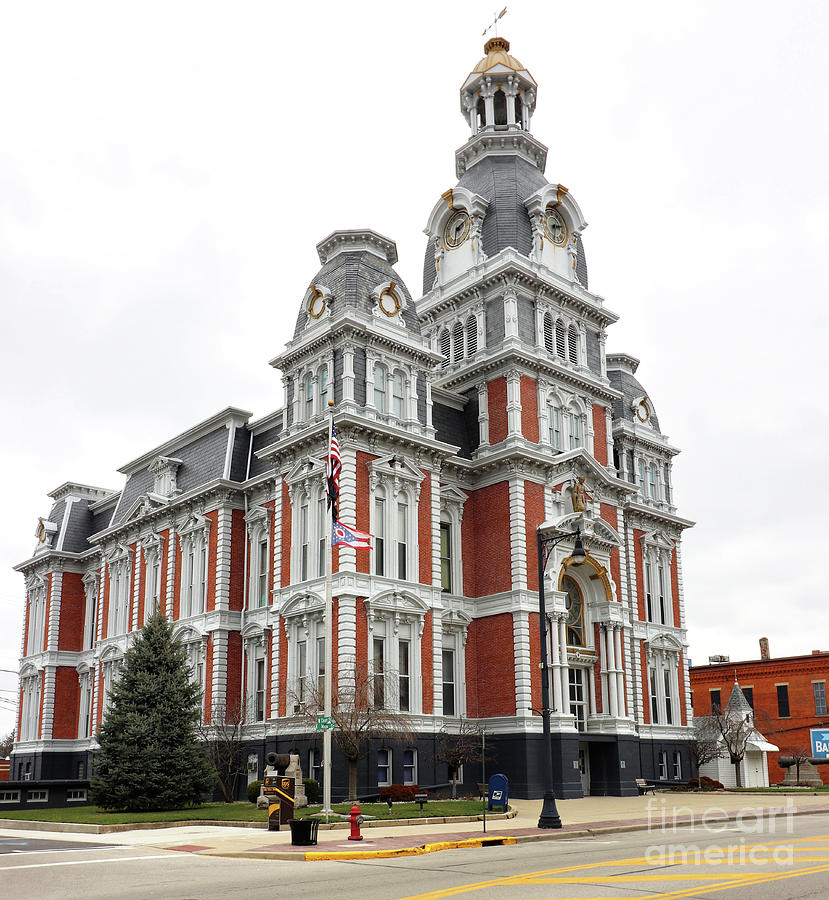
[{"left": 423, "top": 37, "right": 588, "bottom": 294}]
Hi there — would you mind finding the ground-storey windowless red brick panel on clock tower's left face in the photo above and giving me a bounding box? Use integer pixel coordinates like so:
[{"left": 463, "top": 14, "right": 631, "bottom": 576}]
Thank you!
[{"left": 467, "top": 613, "right": 515, "bottom": 716}]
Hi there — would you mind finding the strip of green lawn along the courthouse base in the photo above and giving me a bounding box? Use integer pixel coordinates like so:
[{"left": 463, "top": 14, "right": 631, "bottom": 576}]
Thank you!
[{"left": 0, "top": 800, "right": 492, "bottom": 825}]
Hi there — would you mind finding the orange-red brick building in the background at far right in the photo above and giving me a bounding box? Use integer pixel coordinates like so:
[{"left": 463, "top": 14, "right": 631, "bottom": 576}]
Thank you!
[{"left": 690, "top": 642, "right": 829, "bottom": 784}]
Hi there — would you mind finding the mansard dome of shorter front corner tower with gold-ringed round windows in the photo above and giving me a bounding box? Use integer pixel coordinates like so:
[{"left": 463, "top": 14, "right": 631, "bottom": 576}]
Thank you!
[{"left": 294, "top": 230, "right": 420, "bottom": 339}]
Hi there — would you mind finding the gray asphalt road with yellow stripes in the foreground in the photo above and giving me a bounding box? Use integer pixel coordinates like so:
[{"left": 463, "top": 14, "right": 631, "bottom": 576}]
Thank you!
[{"left": 0, "top": 815, "right": 829, "bottom": 900}]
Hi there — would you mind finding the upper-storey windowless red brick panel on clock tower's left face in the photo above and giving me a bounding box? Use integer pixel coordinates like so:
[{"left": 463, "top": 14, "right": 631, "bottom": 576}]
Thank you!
[{"left": 462, "top": 481, "right": 512, "bottom": 596}]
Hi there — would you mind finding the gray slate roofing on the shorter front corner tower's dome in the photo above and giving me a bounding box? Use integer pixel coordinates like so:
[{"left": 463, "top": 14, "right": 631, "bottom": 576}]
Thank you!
[{"left": 294, "top": 250, "right": 420, "bottom": 338}]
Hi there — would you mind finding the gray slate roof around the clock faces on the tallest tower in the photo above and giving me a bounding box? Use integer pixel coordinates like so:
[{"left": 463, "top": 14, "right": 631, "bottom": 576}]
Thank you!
[{"left": 423, "top": 156, "right": 587, "bottom": 294}]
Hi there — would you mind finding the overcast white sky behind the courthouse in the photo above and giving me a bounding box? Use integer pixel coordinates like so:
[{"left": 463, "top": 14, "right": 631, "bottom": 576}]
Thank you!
[{"left": 0, "top": 0, "right": 829, "bottom": 732}]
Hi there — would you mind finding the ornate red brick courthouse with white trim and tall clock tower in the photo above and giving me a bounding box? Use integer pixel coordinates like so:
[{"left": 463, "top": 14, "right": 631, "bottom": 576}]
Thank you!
[{"left": 12, "top": 37, "right": 693, "bottom": 799}]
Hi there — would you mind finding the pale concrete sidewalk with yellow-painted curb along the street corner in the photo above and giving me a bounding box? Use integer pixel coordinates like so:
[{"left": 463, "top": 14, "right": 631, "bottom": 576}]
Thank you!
[{"left": 0, "top": 792, "right": 829, "bottom": 861}]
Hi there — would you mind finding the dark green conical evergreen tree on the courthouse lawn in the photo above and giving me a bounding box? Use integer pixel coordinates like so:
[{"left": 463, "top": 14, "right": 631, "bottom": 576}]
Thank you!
[{"left": 92, "top": 612, "right": 215, "bottom": 812}]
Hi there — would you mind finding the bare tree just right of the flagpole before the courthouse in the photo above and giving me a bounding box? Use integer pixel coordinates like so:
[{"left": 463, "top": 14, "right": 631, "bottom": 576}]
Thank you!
[{"left": 292, "top": 665, "right": 413, "bottom": 800}]
